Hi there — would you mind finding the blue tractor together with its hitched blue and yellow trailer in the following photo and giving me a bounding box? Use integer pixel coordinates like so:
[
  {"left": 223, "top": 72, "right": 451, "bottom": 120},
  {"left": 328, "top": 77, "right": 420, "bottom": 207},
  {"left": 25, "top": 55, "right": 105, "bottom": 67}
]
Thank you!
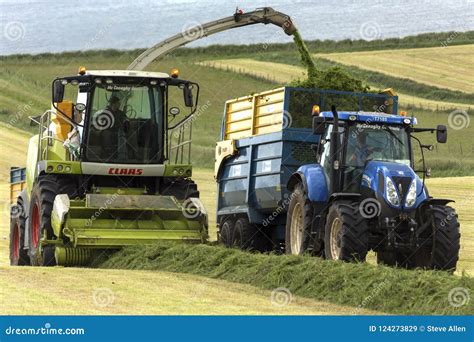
[{"left": 215, "top": 87, "right": 460, "bottom": 270}]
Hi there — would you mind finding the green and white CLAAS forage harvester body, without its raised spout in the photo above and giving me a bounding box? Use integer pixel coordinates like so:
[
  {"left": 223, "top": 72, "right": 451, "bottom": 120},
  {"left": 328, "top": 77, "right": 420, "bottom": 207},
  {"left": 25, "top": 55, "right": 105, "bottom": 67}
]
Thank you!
[{"left": 10, "top": 67, "right": 207, "bottom": 266}]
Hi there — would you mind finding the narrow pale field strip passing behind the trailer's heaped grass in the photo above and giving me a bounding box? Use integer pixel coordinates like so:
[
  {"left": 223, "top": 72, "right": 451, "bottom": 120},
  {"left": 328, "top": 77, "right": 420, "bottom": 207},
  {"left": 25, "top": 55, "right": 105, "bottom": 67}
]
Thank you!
[{"left": 198, "top": 55, "right": 472, "bottom": 110}]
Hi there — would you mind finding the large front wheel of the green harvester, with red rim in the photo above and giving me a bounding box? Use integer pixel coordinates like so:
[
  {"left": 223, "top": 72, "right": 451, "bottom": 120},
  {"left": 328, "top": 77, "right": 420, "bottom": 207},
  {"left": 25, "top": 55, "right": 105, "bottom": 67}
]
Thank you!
[{"left": 28, "top": 175, "right": 76, "bottom": 266}]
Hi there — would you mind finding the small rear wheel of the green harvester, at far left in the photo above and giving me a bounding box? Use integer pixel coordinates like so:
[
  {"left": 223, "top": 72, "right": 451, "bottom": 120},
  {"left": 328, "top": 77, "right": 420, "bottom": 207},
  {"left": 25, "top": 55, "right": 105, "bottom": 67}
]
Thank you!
[{"left": 10, "top": 205, "right": 30, "bottom": 266}]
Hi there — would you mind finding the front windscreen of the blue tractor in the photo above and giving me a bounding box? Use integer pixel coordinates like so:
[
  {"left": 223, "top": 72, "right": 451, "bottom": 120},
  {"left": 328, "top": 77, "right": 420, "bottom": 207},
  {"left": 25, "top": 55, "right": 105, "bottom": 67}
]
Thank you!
[{"left": 345, "top": 123, "right": 410, "bottom": 168}]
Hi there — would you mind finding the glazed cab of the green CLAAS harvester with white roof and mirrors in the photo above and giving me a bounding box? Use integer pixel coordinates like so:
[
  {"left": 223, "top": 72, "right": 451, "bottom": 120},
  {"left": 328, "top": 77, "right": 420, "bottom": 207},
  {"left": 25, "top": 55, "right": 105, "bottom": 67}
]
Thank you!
[{"left": 37, "top": 67, "right": 199, "bottom": 172}]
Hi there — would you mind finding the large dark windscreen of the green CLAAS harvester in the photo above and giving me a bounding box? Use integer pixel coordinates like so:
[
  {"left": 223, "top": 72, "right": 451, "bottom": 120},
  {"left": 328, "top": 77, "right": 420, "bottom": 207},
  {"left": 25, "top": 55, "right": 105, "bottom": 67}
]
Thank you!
[{"left": 85, "top": 84, "right": 164, "bottom": 164}]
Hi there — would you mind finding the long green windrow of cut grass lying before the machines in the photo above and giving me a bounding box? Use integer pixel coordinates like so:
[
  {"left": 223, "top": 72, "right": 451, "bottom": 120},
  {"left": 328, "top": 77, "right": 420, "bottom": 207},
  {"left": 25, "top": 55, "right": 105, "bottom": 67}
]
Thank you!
[{"left": 98, "top": 243, "right": 474, "bottom": 315}]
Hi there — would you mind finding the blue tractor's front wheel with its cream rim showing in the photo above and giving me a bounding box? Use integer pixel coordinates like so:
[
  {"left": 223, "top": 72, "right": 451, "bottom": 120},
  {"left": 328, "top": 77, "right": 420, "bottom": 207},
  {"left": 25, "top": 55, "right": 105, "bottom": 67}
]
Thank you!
[{"left": 324, "top": 201, "right": 369, "bottom": 261}]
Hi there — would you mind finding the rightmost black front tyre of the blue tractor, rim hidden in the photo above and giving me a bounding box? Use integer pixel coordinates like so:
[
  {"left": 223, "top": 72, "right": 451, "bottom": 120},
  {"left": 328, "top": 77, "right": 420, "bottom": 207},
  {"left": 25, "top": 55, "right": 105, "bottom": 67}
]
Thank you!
[{"left": 413, "top": 205, "right": 461, "bottom": 272}]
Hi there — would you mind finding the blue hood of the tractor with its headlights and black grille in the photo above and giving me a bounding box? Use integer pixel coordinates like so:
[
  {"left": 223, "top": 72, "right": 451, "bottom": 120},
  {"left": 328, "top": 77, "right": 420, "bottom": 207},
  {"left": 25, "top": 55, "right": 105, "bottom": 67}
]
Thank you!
[{"left": 361, "top": 161, "right": 428, "bottom": 212}]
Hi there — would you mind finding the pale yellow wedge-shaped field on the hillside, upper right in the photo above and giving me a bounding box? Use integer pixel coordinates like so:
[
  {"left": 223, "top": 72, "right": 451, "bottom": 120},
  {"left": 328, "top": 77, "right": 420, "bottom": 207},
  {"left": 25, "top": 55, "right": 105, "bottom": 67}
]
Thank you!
[{"left": 316, "top": 44, "right": 474, "bottom": 93}]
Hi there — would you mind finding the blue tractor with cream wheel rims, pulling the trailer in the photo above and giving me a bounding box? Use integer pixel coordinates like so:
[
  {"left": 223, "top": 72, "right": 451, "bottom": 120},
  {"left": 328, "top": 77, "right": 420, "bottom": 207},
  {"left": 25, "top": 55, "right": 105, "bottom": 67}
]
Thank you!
[{"left": 285, "top": 106, "right": 460, "bottom": 270}]
